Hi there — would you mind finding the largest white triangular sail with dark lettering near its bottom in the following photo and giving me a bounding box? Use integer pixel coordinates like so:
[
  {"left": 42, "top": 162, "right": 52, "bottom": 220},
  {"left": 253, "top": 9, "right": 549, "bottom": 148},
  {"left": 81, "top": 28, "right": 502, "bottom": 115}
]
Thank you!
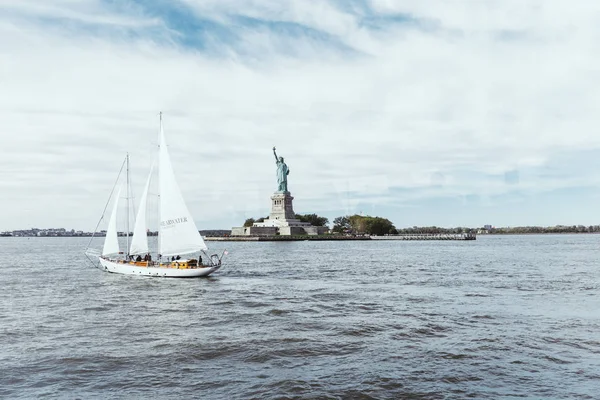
[{"left": 158, "top": 121, "right": 207, "bottom": 256}]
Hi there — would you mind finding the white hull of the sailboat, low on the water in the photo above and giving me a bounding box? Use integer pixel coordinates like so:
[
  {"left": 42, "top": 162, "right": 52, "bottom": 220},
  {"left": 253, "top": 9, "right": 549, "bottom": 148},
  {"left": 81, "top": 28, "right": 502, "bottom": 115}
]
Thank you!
[{"left": 98, "top": 257, "right": 221, "bottom": 278}]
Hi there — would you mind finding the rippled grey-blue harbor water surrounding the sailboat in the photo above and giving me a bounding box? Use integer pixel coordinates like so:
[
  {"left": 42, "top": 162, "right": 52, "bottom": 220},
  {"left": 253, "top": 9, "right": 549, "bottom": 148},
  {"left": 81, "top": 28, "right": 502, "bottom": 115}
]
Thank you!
[{"left": 0, "top": 235, "right": 600, "bottom": 399}]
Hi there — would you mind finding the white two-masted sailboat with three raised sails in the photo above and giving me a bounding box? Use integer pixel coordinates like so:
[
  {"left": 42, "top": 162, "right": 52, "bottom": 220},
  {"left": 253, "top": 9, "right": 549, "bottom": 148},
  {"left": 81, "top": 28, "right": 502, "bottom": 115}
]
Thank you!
[{"left": 86, "top": 113, "right": 227, "bottom": 278}]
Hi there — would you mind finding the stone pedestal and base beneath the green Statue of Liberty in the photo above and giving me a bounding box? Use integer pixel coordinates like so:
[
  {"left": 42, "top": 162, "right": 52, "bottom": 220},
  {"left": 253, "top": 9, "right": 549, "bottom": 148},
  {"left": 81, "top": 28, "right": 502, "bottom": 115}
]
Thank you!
[{"left": 231, "top": 192, "right": 328, "bottom": 236}]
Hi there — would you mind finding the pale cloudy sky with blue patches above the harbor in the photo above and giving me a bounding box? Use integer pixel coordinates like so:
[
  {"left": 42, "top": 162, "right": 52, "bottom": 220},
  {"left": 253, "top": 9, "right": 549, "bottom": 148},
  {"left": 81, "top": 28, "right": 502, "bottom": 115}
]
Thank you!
[{"left": 0, "top": 0, "right": 600, "bottom": 231}]
